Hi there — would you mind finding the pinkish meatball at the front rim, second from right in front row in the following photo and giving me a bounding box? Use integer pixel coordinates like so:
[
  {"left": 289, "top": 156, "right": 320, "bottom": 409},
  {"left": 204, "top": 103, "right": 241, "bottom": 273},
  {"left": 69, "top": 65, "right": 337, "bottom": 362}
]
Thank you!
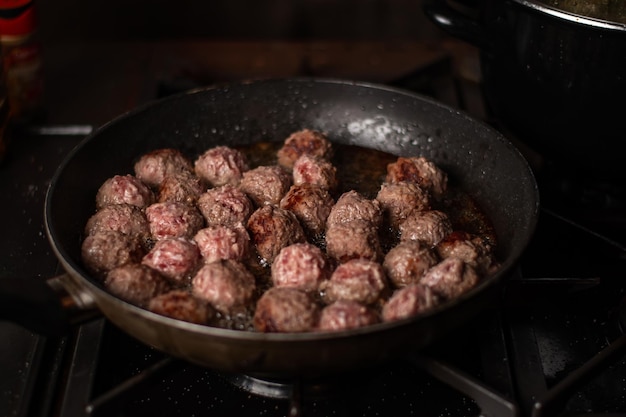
[{"left": 318, "top": 300, "right": 380, "bottom": 331}]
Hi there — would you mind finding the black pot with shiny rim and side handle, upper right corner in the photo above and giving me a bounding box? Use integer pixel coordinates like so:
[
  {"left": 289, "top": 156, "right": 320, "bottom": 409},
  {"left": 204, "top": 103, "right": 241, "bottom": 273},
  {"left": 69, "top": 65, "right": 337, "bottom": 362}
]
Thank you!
[{"left": 424, "top": 0, "right": 626, "bottom": 180}]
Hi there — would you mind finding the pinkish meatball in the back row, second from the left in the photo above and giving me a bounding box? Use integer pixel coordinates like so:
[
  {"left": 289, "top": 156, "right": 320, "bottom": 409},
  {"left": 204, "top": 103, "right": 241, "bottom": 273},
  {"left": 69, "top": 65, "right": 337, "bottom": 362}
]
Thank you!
[{"left": 194, "top": 146, "right": 249, "bottom": 187}]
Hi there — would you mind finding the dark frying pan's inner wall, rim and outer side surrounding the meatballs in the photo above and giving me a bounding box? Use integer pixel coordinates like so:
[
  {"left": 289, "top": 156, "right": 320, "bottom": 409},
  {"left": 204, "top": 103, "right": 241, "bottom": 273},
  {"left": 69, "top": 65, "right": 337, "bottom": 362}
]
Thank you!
[{"left": 0, "top": 78, "right": 538, "bottom": 377}]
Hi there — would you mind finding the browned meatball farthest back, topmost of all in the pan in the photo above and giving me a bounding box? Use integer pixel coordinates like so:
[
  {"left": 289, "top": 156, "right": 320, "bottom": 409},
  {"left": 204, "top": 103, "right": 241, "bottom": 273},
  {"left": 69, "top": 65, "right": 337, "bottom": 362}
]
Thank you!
[{"left": 277, "top": 129, "right": 333, "bottom": 168}]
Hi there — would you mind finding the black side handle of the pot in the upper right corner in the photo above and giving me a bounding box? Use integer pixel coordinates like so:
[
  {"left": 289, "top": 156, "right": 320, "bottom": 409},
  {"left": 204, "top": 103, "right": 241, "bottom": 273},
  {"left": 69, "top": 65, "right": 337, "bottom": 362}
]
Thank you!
[{"left": 422, "top": 0, "right": 489, "bottom": 49}]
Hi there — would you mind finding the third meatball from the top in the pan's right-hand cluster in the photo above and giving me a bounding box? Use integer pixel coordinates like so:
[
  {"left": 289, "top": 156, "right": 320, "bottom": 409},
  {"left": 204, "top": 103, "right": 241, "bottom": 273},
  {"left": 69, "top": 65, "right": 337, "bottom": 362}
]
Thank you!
[{"left": 399, "top": 210, "right": 452, "bottom": 246}]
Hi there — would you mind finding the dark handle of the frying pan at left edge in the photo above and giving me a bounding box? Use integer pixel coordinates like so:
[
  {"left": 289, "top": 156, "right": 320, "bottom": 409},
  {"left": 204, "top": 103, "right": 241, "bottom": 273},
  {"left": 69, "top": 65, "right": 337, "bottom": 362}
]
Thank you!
[{"left": 0, "top": 274, "right": 97, "bottom": 336}]
